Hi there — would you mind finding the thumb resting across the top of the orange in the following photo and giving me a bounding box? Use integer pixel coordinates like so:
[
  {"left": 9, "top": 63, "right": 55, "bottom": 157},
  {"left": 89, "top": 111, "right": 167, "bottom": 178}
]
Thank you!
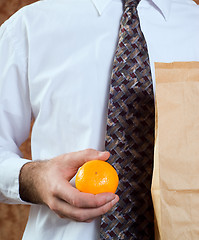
[{"left": 67, "top": 149, "right": 110, "bottom": 169}]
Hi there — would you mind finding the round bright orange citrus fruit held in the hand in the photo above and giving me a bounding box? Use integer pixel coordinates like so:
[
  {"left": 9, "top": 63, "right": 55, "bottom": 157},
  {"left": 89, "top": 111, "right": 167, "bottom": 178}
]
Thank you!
[{"left": 75, "top": 160, "right": 119, "bottom": 194}]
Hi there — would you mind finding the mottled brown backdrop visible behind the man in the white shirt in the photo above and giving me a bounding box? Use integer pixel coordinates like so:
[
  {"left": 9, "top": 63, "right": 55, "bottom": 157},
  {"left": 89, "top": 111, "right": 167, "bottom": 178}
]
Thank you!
[{"left": 0, "top": 0, "right": 199, "bottom": 240}]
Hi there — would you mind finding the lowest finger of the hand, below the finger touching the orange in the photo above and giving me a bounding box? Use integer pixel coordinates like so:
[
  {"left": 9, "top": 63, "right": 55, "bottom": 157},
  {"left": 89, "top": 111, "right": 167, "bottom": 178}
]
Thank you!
[{"left": 53, "top": 195, "right": 119, "bottom": 222}]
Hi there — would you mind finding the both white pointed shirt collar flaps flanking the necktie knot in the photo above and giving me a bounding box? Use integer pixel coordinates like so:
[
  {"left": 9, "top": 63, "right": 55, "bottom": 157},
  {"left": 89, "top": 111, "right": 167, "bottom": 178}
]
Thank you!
[{"left": 91, "top": 0, "right": 172, "bottom": 20}]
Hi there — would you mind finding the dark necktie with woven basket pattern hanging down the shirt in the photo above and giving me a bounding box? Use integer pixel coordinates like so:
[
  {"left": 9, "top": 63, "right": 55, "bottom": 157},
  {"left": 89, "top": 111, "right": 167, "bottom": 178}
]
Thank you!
[{"left": 100, "top": 0, "right": 154, "bottom": 240}]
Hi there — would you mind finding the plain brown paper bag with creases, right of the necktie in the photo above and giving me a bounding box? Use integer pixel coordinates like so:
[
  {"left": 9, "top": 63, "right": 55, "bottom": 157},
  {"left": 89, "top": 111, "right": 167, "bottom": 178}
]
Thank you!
[{"left": 152, "top": 62, "right": 199, "bottom": 240}]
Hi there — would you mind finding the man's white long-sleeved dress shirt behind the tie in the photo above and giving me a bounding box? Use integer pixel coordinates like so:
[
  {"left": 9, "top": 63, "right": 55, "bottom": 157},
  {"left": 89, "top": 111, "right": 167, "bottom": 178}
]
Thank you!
[{"left": 0, "top": 0, "right": 199, "bottom": 240}]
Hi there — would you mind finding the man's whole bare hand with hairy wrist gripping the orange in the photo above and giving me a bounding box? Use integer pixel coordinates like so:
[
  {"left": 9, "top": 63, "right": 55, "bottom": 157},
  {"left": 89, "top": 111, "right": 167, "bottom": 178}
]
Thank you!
[{"left": 19, "top": 149, "right": 119, "bottom": 222}]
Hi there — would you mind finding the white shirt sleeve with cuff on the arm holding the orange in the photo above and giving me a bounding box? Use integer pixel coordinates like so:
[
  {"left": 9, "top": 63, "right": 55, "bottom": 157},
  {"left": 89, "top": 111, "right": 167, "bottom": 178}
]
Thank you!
[{"left": 0, "top": 17, "right": 31, "bottom": 204}]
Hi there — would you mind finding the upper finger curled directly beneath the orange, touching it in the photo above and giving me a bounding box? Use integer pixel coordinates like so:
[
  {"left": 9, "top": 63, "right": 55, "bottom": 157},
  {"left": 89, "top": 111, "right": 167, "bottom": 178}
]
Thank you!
[{"left": 56, "top": 182, "right": 115, "bottom": 208}]
